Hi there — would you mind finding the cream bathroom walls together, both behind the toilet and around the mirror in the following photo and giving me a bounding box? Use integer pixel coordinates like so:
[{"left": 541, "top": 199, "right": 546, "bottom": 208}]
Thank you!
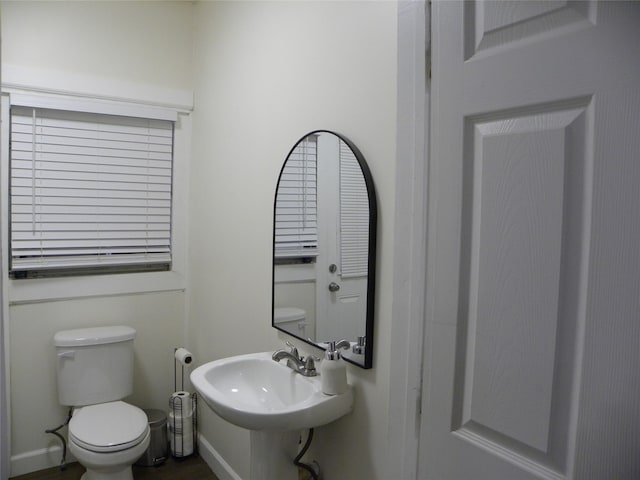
[{"left": 0, "top": 1, "right": 397, "bottom": 480}]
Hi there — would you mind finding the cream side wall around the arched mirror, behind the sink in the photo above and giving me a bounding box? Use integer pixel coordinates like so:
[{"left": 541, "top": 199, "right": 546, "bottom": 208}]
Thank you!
[{"left": 189, "top": 1, "right": 397, "bottom": 480}]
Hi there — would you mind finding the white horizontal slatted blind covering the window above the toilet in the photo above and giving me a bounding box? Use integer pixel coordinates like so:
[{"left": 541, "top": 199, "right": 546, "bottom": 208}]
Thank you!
[{"left": 10, "top": 106, "right": 173, "bottom": 277}]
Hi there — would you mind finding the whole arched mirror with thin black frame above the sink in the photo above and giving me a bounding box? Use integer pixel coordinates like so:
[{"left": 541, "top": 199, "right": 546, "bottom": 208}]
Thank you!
[{"left": 272, "top": 130, "right": 377, "bottom": 368}]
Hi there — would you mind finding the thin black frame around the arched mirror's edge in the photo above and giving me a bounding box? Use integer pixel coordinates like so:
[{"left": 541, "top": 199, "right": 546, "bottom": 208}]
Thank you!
[{"left": 271, "top": 130, "right": 378, "bottom": 369}]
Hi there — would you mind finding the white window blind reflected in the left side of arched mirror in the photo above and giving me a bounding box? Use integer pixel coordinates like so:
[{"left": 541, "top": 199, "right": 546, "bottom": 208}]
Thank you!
[{"left": 275, "top": 136, "right": 318, "bottom": 258}]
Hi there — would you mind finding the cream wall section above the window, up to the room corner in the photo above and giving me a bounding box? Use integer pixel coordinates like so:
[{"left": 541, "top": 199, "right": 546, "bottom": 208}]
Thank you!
[{"left": 1, "top": 0, "right": 192, "bottom": 89}]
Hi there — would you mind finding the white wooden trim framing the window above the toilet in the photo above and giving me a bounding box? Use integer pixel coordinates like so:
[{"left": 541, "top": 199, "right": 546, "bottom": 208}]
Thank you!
[{"left": 0, "top": 89, "right": 191, "bottom": 304}]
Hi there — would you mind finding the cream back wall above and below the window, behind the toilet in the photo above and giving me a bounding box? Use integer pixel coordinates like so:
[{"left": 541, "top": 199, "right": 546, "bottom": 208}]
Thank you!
[{"left": 0, "top": 1, "right": 193, "bottom": 475}]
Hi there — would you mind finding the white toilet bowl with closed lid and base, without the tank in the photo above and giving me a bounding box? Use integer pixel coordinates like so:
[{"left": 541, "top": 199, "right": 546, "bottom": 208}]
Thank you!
[{"left": 69, "top": 401, "right": 151, "bottom": 480}]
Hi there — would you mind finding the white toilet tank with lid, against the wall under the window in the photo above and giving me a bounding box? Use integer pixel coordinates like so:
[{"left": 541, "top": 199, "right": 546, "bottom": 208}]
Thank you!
[{"left": 53, "top": 326, "right": 136, "bottom": 406}]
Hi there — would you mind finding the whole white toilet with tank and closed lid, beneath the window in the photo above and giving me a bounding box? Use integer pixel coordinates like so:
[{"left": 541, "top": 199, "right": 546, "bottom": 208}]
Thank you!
[{"left": 54, "top": 326, "right": 150, "bottom": 480}]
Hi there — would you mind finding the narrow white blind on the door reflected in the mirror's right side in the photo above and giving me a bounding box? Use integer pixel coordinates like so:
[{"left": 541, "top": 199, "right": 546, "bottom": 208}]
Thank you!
[{"left": 340, "top": 140, "right": 369, "bottom": 278}]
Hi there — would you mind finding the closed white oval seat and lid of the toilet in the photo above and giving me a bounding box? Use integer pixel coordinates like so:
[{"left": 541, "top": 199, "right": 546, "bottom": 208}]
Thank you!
[{"left": 69, "top": 401, "right": 149, "bottom": 453}]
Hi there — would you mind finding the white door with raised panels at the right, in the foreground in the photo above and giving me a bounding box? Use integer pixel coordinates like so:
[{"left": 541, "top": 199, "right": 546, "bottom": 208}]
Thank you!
[{"left": 418, "top": 1, "right": 640, "bottom": 480}]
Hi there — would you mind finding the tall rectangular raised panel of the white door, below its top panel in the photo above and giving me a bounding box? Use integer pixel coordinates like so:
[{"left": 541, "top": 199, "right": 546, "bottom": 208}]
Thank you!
[{"left": 453, "top": 99, "right": 588, "bottom": 466}]
